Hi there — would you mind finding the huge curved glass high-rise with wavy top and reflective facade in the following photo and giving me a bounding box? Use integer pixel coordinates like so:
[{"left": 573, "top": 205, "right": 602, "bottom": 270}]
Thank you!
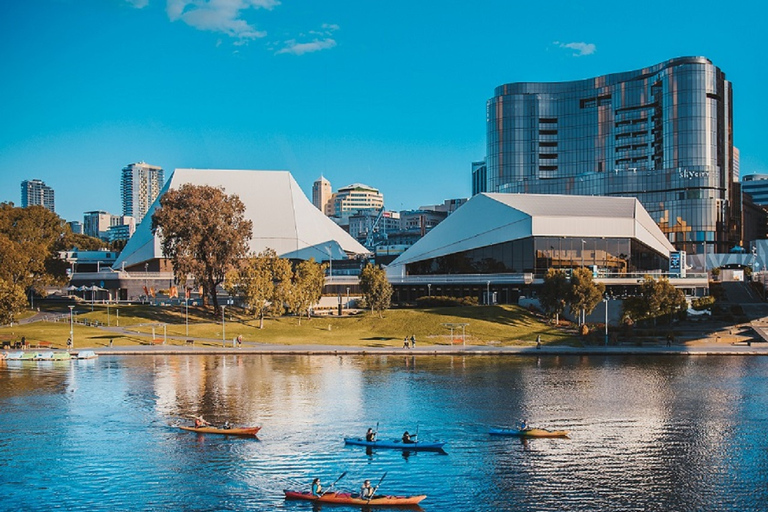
[{"left": 486, "top": 57, "right": 741, "bottom": 253}]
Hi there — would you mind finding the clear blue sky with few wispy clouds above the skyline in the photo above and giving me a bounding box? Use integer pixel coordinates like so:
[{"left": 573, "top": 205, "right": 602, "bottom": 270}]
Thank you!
[{"left": 0, "top": 0, "right": 768, "bottom": 220}]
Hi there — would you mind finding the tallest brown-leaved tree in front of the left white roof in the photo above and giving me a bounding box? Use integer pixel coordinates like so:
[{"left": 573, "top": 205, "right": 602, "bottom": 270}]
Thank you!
[{"left": 152, "top": 183, "right": 253, "bottom": 310}]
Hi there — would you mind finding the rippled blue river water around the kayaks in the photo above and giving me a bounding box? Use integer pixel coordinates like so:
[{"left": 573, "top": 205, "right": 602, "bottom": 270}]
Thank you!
[{"left": 0, "top": 355, "right": 768, "bottom": 512}]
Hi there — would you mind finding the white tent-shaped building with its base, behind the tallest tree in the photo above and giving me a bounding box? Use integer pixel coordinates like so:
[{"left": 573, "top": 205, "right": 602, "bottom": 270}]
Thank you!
[{"left": 71, "top": 169, "right": 369, "bottom": 300}]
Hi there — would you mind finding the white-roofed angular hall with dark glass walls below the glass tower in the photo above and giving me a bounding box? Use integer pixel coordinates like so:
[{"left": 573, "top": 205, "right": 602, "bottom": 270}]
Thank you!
[{"left": 386, "top": 193, "right": 707, "bottom": 303}]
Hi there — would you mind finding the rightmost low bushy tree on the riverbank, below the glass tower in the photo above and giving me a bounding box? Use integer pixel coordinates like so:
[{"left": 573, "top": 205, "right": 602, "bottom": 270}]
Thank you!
[{"left": 622, "top": 276, "right": 688, "bottom": 325}]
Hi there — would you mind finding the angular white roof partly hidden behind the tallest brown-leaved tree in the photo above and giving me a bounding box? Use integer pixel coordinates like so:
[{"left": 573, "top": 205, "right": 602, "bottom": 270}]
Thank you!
[{"left": 113, "top": 169, "right": 369, "bottom": 268}]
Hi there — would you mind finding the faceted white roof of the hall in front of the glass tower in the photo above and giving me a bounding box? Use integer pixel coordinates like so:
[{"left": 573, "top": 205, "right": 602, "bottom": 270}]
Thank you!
[{"left": 387, "top": 193, "right": 675, "bottom": 276}]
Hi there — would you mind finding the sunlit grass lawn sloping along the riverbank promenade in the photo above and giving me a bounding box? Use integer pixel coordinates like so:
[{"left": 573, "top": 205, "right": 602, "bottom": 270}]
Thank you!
[{"left": 0, "top": 304, "right": 576, "bottom": 348}]
